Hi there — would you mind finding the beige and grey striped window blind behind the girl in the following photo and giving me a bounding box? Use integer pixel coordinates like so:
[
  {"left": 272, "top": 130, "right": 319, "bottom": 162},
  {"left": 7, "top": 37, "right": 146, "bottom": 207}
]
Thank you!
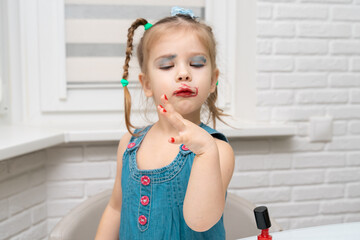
[{"left": 65, "top": 0, "right": 205, "bottom": 85}]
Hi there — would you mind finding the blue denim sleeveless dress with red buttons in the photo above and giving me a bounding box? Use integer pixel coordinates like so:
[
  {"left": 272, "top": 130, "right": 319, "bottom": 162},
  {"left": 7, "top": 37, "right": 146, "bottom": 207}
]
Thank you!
[{"left": 119, "top": 123, "right": 228, "bottom": 240}]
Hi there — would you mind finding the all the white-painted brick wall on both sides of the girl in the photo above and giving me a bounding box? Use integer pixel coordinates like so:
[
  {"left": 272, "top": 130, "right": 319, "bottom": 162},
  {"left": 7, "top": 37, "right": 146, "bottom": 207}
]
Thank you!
[{"left": 0, "top": 0, "right": 360, "bottom": 240}]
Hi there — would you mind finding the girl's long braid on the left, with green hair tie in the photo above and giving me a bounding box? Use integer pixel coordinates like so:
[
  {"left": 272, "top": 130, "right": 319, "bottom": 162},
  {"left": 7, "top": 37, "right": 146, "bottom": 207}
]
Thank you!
[{"left": 122, "top": 18, "right": 147, "bottom": 136}]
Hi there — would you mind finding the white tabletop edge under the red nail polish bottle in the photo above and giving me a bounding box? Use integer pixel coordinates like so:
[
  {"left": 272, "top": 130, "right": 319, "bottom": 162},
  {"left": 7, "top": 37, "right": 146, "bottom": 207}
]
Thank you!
[{"left": 239, "top": 222, "right": 360, "bottom": 240}]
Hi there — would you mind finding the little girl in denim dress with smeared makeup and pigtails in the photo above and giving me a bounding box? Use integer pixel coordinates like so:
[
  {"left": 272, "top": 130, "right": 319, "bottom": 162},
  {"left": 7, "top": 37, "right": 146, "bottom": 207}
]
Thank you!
[{"left": 96, "top": 8, "right": 234, "bottom": 240}]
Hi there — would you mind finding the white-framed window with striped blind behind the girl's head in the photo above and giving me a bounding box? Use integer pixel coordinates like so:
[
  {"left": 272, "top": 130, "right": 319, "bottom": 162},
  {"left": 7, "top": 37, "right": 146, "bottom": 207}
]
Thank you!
[{"left": 9, "top": 0, "right": 256, "bottom": 127}]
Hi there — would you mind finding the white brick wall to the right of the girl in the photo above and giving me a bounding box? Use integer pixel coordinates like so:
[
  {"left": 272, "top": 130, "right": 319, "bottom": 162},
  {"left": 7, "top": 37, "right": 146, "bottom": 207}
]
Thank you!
[{"left": 253, "top": 0, "right": 360, "bottom": 229}]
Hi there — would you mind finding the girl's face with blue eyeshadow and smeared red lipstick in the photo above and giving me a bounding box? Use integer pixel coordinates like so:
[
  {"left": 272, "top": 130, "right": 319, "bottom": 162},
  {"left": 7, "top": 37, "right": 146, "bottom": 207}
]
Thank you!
[{"left": 139, "top": 30, "right": 219, "bottom": 115}]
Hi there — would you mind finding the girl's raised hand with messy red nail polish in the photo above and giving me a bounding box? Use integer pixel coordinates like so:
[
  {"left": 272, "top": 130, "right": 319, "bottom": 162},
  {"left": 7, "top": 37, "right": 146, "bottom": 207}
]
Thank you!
[{"left": 157, "top": 94, "right": 217, "bottom": 155}]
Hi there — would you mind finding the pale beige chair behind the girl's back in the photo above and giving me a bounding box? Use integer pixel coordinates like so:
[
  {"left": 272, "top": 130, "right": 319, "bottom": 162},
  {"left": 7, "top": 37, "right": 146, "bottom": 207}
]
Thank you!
[{"left": 49, "top": 190, "right": 282, "bottom": 240}]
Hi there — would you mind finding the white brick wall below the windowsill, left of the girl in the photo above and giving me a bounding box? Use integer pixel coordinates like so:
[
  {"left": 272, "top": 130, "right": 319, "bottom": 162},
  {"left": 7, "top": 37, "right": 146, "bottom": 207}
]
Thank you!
[{"left": 0, "top": 142, "right": 118, "bottom": 240}]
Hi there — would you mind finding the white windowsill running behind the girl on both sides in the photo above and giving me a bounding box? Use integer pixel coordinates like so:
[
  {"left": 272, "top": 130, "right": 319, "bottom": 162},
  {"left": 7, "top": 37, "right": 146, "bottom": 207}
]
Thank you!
[{"left": 0, "top": 123, "right": 296, "bottom": 161}]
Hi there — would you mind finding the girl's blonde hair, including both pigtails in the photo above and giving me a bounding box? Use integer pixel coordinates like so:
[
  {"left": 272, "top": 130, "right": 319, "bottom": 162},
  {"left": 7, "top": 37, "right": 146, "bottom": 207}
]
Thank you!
[{"left": 123, "top": 14, "right": 228, "bottom": 136}]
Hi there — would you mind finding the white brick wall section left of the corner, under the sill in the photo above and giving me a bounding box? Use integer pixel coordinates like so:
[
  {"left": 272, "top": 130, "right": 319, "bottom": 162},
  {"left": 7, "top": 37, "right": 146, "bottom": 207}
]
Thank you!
[{"left": 0, "top": 151, "right": 48, "bottom": 240}]
